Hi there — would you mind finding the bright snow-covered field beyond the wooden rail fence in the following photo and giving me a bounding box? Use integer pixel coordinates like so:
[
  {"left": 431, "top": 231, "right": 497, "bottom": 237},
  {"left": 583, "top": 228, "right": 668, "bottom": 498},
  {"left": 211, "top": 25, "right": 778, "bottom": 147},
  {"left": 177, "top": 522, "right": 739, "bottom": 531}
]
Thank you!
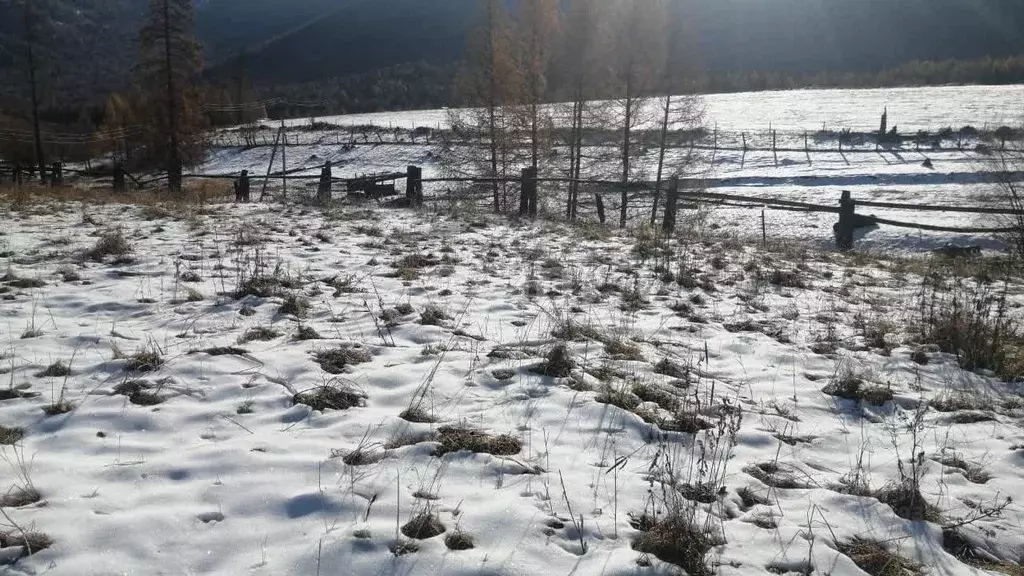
[{"left": 201, "top": 86, "right": 1024, "bottom": 252}]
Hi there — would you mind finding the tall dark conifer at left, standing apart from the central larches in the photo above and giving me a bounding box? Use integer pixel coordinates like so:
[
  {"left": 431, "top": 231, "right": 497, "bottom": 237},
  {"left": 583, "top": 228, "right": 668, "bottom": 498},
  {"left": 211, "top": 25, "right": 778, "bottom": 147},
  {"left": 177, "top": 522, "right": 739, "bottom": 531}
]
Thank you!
[{"left": 139, "top": 0, "right": 202, "bottom": 193}]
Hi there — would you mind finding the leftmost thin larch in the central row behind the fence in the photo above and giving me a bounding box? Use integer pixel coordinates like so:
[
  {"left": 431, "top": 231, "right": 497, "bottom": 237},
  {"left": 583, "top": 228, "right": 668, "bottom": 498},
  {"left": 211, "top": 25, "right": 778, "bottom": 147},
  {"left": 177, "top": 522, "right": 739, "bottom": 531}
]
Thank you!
[{"left": 441, "top": 0, "right": 523, "bottom": 212}]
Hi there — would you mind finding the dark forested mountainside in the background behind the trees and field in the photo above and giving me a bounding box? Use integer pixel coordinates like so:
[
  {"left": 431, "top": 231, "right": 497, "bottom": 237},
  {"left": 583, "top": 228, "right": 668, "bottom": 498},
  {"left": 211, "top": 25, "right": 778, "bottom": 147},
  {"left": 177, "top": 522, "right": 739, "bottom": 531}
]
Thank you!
[{"left": 0, "top": 0, "right": 1024, "bottom": 114}]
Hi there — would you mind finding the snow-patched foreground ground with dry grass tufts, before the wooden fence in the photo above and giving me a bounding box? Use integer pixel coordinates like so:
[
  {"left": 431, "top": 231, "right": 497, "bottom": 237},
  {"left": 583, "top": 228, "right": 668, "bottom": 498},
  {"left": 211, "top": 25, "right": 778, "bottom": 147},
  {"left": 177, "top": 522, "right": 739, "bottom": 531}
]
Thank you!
[{"left": 0, "top": 194, "right": 1024, "bottom": 576}]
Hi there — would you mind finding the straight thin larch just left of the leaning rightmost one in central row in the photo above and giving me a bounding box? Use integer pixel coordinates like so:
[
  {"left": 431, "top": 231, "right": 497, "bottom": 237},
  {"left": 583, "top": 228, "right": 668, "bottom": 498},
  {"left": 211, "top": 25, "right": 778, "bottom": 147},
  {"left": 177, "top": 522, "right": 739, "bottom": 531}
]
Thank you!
[{"left": 611, "top": 0, "right": 667, "bottom": 228}]
